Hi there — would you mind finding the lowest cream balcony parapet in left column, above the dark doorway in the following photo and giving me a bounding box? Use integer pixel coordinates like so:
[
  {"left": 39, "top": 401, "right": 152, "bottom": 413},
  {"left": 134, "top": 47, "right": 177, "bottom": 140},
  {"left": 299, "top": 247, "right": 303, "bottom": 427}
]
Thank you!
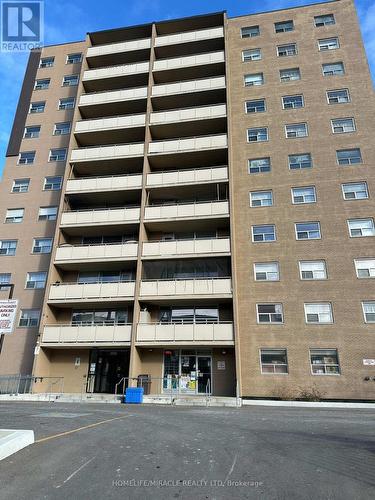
[{"left": 41, "top": 324, "right": 132, "bottom": 347}]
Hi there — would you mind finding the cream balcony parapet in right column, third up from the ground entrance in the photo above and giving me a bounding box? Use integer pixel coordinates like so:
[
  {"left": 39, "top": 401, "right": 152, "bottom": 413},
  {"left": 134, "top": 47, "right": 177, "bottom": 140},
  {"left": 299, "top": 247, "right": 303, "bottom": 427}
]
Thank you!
[{"left": 142, "top": 238, "right": 230, "bottom": 259}]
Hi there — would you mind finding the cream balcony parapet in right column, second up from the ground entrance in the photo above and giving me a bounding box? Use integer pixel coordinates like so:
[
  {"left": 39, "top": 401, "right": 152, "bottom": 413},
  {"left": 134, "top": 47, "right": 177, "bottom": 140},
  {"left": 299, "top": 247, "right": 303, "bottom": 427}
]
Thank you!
[{"left": 140, "top": 278, "right": 232, "bottom": 300}]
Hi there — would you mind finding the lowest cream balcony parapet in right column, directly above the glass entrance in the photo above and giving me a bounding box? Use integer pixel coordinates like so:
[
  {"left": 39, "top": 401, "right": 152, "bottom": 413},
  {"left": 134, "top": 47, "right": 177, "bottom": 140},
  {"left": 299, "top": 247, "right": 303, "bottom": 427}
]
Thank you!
[{"left": 136, "top": 322, "right": 234, "bottom": 346}]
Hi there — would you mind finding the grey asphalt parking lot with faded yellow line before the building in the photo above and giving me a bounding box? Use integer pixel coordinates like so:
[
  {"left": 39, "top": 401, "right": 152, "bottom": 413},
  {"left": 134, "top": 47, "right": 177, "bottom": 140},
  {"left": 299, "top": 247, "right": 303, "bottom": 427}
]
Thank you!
[{"left": 0, "top": 402, "right": 375, "bottom": 500}]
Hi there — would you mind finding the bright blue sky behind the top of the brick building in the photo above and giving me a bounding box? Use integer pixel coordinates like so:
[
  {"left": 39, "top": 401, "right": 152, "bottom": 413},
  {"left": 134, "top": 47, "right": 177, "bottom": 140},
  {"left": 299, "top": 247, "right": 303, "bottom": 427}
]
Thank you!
[{"left": 0, "top": 0, "right": 375, "bottom": 175}]
